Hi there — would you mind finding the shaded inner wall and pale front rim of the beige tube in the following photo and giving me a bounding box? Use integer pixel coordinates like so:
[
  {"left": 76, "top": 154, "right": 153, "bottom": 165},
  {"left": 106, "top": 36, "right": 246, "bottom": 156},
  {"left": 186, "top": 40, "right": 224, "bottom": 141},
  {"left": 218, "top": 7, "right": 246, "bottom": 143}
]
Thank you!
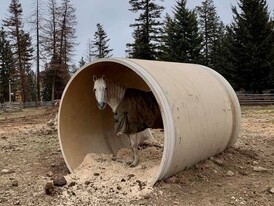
[{"left": 58, "top": 59, "right": 174, "bottom": 184}]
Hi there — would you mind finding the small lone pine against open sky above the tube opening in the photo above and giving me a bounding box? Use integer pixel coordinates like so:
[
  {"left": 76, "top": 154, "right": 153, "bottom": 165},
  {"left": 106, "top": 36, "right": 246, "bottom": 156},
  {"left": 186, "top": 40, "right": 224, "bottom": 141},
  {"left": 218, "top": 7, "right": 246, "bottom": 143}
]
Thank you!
[{"left": 89, "top": 23, "right": 113, "bottom": 59}]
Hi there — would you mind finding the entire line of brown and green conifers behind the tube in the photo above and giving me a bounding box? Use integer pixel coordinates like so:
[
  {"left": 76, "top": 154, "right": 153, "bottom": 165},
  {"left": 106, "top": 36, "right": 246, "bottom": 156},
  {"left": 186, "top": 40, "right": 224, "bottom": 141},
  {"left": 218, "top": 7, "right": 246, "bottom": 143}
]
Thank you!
[{"left": 0, "top": 0, "right": 274, "bottom": 102}]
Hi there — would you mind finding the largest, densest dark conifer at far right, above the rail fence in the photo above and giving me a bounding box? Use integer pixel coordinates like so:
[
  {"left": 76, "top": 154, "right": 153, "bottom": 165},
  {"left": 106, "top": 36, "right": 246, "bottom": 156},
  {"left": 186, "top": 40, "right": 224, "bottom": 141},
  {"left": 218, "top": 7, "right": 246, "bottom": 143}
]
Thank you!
[{"left": 229, "top": 0, "right": 274, "bottom": 93}]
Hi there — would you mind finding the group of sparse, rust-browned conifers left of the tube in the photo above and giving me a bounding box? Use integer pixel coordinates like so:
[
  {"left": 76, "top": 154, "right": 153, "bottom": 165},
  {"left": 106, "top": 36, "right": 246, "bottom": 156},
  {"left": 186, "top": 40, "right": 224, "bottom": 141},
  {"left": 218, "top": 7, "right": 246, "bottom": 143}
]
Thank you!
[{"left": 0, "top": 0, "right": 77, "bottom": 102}]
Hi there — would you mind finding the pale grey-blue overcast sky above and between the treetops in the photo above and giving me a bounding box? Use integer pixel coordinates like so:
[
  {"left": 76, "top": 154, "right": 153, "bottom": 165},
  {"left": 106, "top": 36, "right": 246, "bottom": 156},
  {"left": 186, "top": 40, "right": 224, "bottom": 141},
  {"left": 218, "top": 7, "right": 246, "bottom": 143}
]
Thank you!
[{"left": 0, "top": 0, "right": 274, "bottom": 65}]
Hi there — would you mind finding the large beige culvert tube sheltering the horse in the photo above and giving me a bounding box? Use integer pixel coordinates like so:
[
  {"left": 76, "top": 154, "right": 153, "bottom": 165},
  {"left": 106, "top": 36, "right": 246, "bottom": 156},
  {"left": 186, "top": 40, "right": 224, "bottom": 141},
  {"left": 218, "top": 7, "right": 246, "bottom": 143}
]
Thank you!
[{"left": 58, "top": 58, "right": 241, "bottom": 183}]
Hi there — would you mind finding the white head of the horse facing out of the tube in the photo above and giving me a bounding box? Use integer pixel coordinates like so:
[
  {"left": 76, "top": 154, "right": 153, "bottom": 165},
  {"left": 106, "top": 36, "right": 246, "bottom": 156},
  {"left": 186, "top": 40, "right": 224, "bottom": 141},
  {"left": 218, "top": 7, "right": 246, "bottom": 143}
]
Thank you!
[{"left": 93, "top": 75, "right": 107, "bottom": 109}]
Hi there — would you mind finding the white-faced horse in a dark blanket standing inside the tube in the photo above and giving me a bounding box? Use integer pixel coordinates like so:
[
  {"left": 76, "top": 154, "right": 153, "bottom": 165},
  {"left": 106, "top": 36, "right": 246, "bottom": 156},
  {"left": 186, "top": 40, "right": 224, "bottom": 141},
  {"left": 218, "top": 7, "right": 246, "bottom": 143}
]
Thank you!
[{"left": 93, "top": 75, "right": 163, "bottom": 167}]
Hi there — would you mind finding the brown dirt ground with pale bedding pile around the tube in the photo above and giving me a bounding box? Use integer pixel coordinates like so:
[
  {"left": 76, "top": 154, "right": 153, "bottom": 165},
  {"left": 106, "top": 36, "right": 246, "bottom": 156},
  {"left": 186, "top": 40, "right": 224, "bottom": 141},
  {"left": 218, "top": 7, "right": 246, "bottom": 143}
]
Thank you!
[{"left": 0, "top": 106, "right": 274, "bottom": 206}]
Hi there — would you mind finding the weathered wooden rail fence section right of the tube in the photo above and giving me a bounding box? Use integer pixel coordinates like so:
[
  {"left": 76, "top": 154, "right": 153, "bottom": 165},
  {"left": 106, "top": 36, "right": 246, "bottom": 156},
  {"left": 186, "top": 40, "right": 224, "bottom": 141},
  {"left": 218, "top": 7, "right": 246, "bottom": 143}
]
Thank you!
[{"left": 237, "top": 93, "right": 274, "bottom": 105}]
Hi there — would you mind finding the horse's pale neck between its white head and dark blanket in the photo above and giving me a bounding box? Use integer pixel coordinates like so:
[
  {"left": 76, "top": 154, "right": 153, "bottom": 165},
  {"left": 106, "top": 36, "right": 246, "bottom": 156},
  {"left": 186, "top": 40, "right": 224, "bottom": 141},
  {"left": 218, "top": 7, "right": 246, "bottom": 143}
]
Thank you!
[{"left": 106, "top": 80, "right": 126, "bottom": 112}]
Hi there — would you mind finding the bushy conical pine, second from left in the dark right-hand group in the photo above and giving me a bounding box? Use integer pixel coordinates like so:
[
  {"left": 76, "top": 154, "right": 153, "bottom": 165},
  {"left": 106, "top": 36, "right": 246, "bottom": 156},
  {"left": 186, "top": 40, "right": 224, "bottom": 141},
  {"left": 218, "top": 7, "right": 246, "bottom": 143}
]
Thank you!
[{"left": 161, "top": 0, "right": 202, "bottom": 63}]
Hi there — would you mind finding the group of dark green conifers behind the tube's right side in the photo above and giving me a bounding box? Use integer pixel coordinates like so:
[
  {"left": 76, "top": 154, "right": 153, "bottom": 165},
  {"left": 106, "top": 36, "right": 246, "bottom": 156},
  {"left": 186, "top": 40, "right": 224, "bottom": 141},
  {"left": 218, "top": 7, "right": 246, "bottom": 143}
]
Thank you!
[{"left": 122, "top": 0, "right": 274, "bottom": 93}]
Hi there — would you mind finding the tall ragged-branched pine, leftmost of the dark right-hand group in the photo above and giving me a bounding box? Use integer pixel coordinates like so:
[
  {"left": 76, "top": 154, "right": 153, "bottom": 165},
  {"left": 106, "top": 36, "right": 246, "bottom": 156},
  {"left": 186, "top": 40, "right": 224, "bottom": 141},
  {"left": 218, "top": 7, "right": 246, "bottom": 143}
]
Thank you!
[{"left": 126, "top": 0, "right": 164, "bottom": 59}]
